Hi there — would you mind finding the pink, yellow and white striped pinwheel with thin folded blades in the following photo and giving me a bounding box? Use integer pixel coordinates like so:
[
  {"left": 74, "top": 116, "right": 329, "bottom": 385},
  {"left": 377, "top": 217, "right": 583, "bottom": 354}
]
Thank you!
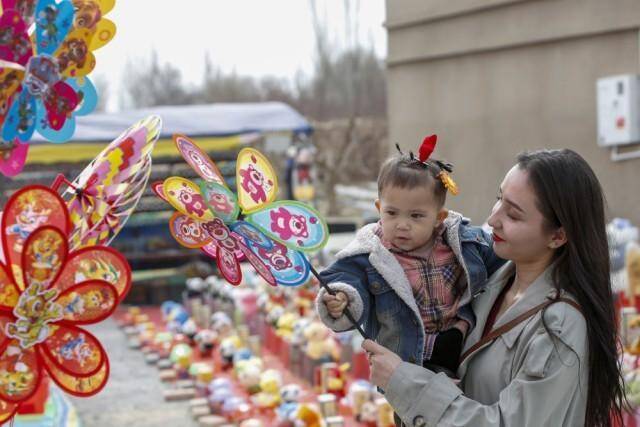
[{"left": 52, "top": 116, "right": 162, "bottom": 249}]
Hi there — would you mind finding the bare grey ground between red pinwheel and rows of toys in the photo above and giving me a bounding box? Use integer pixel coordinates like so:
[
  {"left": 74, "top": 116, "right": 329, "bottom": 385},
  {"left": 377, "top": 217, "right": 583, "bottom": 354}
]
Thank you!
[{"left": 70, "top": 319, "right": 198, "bottom": 427}]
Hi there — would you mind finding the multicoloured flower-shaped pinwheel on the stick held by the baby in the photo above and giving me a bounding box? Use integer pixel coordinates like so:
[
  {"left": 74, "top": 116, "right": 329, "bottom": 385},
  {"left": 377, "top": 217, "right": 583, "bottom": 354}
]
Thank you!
[{"left": 153, "top": 135, "right": 328, "bottom": 286}]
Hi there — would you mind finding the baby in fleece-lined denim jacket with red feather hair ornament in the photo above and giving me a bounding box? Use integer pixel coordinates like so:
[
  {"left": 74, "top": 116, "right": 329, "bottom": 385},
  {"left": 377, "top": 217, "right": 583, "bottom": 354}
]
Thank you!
[{"left": 316, "top": 135, "right": 504, "bottom": 376}]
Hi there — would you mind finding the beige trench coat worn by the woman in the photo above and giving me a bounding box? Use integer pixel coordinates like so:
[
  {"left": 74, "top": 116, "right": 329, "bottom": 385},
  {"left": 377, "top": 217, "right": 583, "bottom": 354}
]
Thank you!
[{"left": 385, "top": 263, "right": 589, "bottom": 427}]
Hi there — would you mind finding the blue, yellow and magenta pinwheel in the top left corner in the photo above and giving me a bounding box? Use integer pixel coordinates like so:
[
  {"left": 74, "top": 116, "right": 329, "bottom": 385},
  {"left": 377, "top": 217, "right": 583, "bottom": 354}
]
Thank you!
[{"left": 0, "top": 0, "right": 116, "bottom": 175}]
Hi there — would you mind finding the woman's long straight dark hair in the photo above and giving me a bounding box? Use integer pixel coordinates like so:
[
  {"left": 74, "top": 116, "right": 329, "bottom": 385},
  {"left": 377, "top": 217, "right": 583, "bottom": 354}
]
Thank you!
[{"left": 518, "top": 149, "right": 627, "bottom": 427}]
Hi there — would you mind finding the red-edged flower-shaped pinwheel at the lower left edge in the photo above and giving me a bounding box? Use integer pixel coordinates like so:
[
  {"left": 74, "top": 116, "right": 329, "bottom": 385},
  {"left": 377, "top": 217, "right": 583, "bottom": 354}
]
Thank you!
[{"left": 0, "top": 186, "right": 131, "bottom": 422}]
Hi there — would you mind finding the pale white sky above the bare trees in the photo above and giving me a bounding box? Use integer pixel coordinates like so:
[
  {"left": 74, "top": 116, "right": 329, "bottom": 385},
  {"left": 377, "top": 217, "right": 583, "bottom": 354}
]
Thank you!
[{"left": 92, "top": 0, "right": 387, "bottom": 111}]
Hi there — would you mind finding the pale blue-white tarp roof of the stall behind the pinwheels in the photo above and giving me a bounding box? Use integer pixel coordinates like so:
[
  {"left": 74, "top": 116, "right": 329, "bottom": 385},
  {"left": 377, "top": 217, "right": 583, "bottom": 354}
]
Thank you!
[{"left": 31, "top": 102, "right": 312, "bottom": 144}]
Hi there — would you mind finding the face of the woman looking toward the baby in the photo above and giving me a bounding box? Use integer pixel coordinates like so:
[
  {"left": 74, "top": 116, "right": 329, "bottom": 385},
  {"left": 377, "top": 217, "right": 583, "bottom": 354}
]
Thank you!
[{"left": 487, "top": 165, "right": 557, "bottom": 264}]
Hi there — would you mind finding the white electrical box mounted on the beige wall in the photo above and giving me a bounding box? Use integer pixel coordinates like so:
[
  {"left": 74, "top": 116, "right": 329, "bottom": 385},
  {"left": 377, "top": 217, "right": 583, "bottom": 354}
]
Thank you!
[{"left": 597, "top": 74, "right": 640, "bottom": 147}]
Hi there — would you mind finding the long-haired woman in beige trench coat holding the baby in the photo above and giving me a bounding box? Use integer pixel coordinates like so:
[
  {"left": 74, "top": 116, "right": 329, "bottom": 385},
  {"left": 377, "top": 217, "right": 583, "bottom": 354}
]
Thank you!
[{"left": 363, "top": 150, "right": 626, "bottom": 427}]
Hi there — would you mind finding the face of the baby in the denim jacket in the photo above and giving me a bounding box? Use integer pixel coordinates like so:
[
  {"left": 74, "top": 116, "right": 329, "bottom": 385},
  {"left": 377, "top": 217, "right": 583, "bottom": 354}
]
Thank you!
[{"left": 376, "top": 186, "right": 445, "bottom": 251}]
